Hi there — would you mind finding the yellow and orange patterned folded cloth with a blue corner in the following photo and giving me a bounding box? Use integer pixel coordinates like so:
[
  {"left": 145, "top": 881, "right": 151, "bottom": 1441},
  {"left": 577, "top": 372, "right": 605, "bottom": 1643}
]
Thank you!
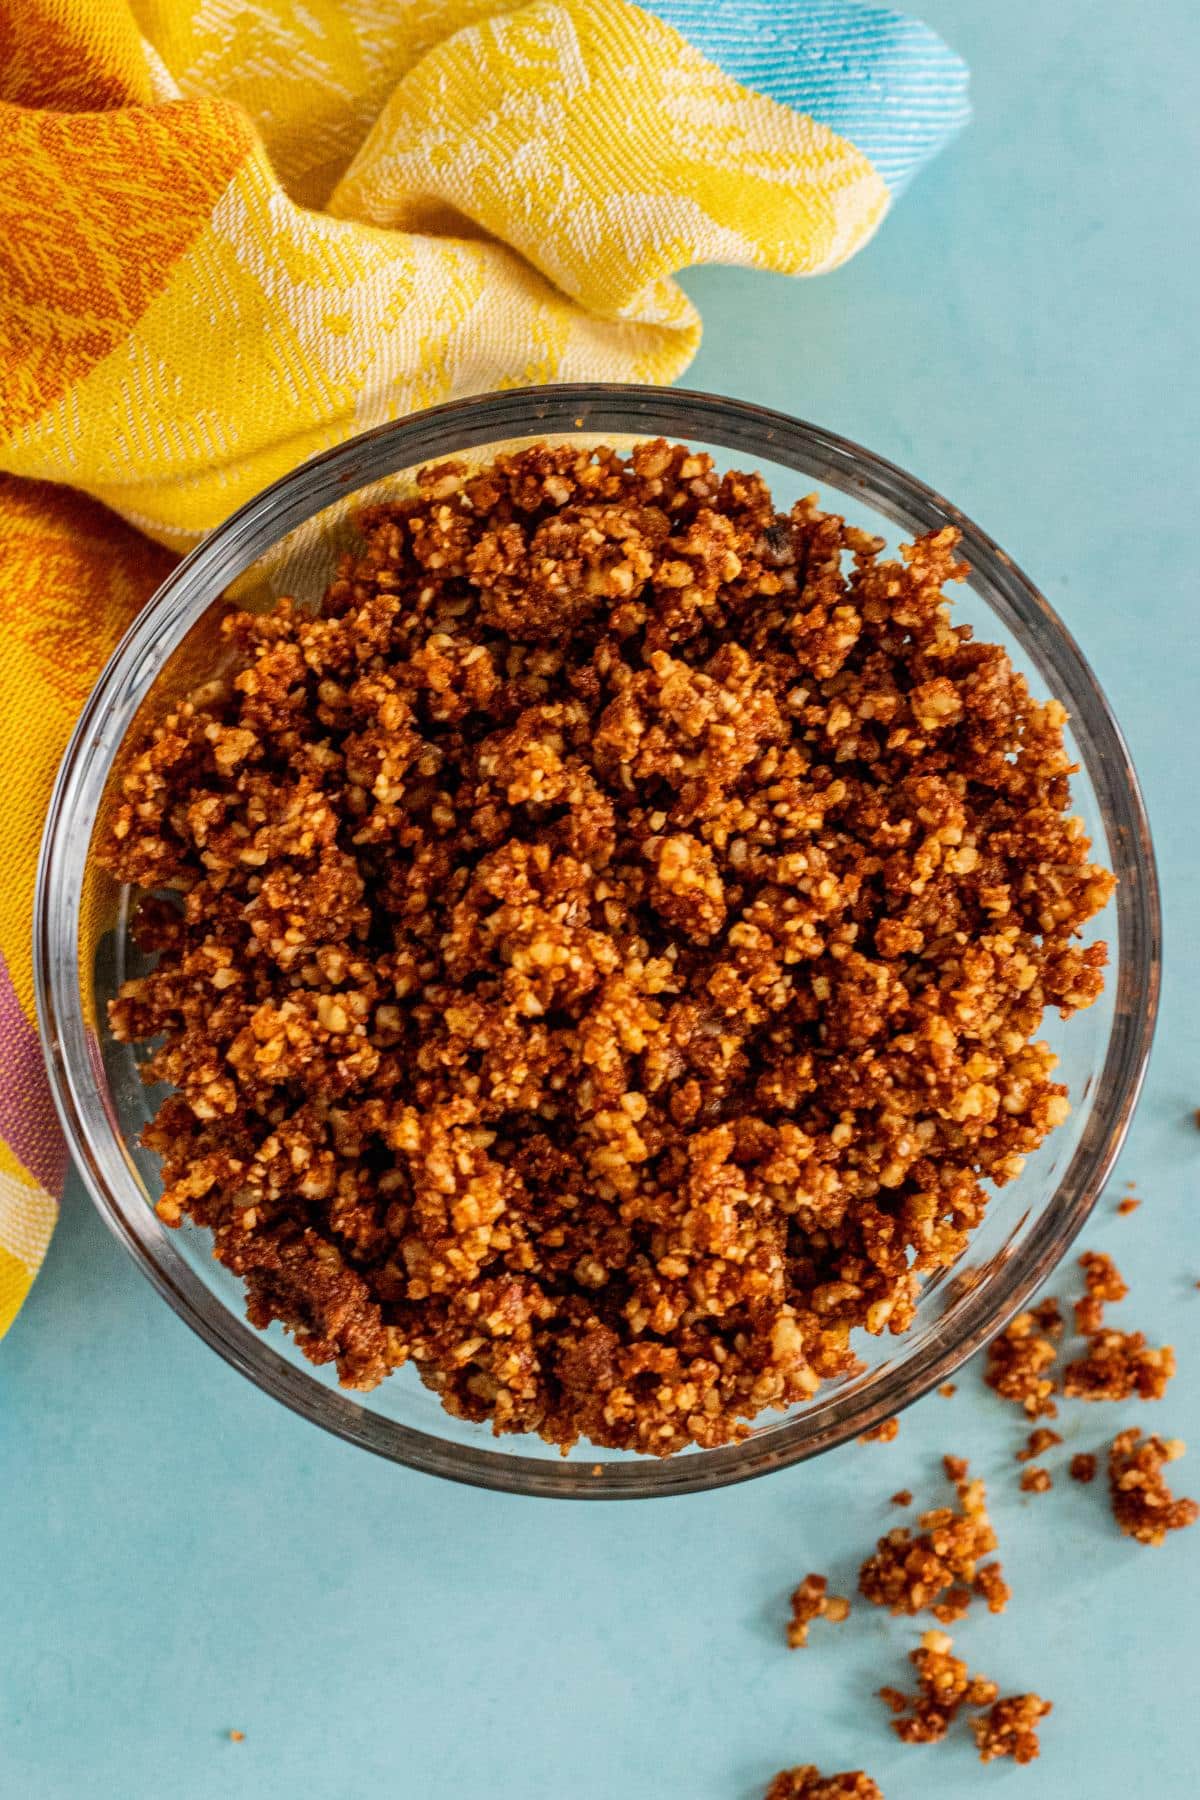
[{"left": 0, "top": 0, "right": 968, "bottom": 1332}]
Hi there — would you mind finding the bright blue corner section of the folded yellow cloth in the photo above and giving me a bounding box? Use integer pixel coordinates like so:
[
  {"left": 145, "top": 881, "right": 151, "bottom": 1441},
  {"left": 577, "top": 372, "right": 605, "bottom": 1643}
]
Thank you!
[{"left": 648, "top": 0, "right": 972, "bottom": 194}]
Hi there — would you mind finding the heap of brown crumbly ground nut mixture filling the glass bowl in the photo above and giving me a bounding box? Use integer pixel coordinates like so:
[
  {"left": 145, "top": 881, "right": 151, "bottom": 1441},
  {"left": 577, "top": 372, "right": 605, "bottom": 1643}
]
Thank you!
[{"left": 101, "top": 443, "right": 1112, "bottom": 1454}]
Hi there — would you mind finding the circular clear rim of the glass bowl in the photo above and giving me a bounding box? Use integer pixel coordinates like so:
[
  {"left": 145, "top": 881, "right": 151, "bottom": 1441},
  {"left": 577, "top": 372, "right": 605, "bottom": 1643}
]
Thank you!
[{"left": 34, "top": 382, "right": 1160, "bottom": 1499}]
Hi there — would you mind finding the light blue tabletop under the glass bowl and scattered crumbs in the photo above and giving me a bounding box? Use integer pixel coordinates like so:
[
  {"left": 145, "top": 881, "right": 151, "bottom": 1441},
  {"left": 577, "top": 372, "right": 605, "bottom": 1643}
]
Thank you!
[{"left": 0, "top": 0, "right": 1200, "bottom": 1800}]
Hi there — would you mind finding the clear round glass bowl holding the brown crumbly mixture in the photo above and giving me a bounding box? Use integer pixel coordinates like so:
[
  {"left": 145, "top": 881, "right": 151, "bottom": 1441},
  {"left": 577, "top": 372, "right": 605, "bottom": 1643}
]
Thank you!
[{"left": 34, "top": 383, "right": 1160, "bottom": 1499}]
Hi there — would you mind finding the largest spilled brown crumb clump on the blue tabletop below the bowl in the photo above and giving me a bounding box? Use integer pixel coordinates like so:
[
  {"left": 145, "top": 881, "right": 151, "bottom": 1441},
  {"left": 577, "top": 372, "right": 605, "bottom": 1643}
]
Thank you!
[{"left": 858, "top": 1456, "right": 1007, "bottom": 1618}]
